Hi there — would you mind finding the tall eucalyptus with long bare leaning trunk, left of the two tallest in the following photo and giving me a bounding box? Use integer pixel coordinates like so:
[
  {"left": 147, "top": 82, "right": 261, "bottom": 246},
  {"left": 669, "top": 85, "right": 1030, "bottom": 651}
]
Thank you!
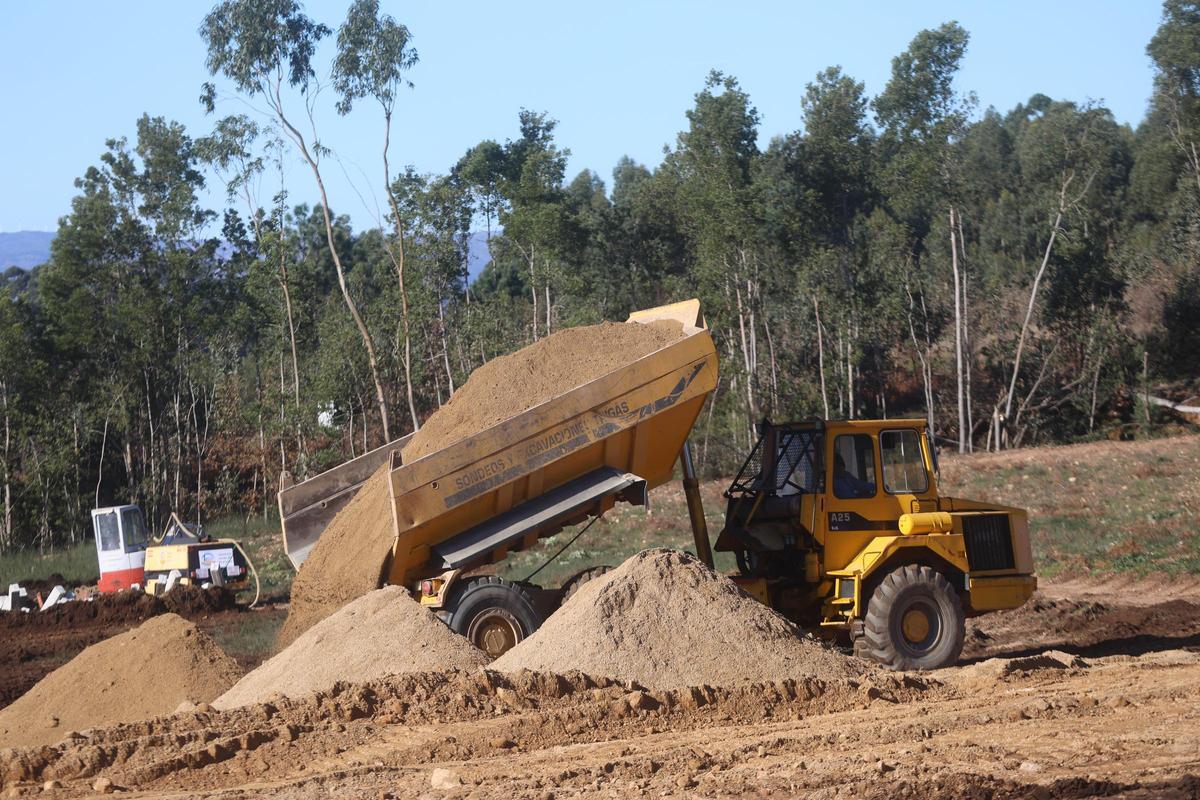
[{"left": 200, "top": 0, "right": 391, "bottom": 440}]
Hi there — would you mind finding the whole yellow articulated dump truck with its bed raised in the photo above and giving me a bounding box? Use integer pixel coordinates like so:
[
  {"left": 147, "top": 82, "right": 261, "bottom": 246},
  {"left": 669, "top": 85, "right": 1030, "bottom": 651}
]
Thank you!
[{"left": 278, "top": 300, "right": 1036, "bottom": 669}]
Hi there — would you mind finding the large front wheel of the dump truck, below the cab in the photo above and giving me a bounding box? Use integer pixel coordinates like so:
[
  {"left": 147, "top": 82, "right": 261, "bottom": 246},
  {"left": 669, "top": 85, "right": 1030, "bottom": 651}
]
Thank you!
[{"left": 854, "top": 565, "right": 966, "bottom": 669}]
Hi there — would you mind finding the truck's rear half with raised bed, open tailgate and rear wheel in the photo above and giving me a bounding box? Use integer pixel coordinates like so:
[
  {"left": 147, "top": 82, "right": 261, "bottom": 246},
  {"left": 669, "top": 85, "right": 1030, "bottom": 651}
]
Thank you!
[{"left": 280, "top": 300, "right": 718, "bottom": 655}]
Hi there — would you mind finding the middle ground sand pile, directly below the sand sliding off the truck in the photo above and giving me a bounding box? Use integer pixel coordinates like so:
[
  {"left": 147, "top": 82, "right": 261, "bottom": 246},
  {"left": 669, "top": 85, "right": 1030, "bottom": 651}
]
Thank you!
[{"left": 212, "top": 587, "right": 487, "bottom": 709}]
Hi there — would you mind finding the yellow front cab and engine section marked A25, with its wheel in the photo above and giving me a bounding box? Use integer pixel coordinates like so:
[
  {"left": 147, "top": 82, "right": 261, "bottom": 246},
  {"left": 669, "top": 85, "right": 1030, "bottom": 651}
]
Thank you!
[{"left": 715, "top": 420, "right": 1037, "bottom": 669}]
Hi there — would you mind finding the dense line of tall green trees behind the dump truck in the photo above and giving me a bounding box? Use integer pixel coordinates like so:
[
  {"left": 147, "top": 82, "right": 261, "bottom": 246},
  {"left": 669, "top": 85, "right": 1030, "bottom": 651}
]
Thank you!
[{"left": 0, "top": 0, "right": 1200, "bottom": 552}]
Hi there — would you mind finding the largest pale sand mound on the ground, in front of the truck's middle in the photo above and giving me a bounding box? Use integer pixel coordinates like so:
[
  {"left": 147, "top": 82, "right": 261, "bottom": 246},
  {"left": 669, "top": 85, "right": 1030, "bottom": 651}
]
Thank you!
[{"left": 492, "top": 549, "right": 871, "bottom": 688}]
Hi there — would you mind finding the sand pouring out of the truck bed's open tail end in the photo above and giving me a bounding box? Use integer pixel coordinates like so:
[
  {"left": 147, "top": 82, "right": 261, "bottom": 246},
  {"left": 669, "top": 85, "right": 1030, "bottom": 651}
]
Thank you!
[{"left": 276, "top": 464, "right": 396, "bottom": 649}]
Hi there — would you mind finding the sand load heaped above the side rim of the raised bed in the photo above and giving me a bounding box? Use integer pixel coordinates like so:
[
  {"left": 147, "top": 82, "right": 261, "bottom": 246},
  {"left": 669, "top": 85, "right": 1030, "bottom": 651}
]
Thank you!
[{"left": 403, "top": 320, "right": 683, "bottom": 464}]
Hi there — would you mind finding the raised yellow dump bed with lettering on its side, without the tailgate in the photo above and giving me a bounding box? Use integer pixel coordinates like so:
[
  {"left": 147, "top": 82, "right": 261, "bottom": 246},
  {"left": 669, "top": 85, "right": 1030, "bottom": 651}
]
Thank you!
[{"left": 389, "top": 300, "right": 716, "bottom": 585}]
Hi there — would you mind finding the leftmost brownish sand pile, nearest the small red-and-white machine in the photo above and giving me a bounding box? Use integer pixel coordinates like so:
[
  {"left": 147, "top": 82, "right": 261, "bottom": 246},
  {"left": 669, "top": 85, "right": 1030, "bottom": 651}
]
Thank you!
[{"left": 0, "top": 614, "right": 241, "bottom": 747}]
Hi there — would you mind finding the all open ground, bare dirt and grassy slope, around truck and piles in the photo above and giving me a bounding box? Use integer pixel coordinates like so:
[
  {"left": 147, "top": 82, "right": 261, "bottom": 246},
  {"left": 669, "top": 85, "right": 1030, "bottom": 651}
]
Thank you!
[{"left": 0, "top": 437, "right": 1200, "bottom": 800}]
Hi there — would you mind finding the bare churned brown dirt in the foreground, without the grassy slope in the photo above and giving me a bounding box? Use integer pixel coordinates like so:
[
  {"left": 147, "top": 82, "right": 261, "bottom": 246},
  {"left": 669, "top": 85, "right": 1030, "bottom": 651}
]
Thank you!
[{"left": 0, "top": 578, "right": 1200, "bottom": 800}]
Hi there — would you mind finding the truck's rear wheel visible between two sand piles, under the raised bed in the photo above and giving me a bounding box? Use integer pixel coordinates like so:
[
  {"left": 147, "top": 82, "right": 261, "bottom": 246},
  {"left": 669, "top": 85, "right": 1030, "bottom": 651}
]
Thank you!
[{"left": 450, "top": 576, "right": 541, "bottom": 658}]
